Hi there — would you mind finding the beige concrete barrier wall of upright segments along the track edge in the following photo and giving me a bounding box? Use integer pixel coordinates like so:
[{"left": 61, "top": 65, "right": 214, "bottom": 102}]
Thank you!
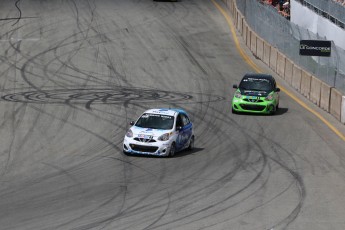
[{"left": 222, "top": 0, "right": 345, "bottom": 124}]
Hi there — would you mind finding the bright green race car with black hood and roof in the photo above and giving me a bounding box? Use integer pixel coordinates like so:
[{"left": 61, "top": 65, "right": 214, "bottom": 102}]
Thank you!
[{"left": 232, "top": 73, "right": 280, "bottom": 114}]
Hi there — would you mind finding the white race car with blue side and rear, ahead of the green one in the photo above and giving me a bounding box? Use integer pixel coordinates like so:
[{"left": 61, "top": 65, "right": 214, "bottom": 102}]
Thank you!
[{"left": 123, "top": 109, "right": 195, "bottom": 157}]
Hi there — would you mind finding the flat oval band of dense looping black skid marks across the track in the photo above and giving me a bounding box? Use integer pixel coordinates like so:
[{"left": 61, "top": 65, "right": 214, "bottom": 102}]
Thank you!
[{"left": 1, "top": 87, "right": 225, "bottom": 109}]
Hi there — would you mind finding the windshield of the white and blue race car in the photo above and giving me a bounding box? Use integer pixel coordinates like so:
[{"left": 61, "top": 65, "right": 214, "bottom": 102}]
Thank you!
[{"left": 135, "top": 113, "right": 174, "bottom": 129}]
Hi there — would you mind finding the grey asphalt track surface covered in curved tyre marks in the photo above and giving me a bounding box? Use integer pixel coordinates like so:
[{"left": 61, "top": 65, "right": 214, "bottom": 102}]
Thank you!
[{"left": 0, "top": 0, "right": 345, "bottom": 230}]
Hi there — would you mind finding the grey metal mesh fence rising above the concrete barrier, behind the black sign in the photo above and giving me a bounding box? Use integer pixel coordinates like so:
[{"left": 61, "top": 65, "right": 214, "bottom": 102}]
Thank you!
[{"left": 236, "top": 0, "right": 345, "bottom": 93}]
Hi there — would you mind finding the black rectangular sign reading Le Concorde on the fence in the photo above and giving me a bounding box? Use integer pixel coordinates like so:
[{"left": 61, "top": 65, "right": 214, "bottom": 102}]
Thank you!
[{"left": 299, "top": 40, "right": 332, "bottom": 57}]
